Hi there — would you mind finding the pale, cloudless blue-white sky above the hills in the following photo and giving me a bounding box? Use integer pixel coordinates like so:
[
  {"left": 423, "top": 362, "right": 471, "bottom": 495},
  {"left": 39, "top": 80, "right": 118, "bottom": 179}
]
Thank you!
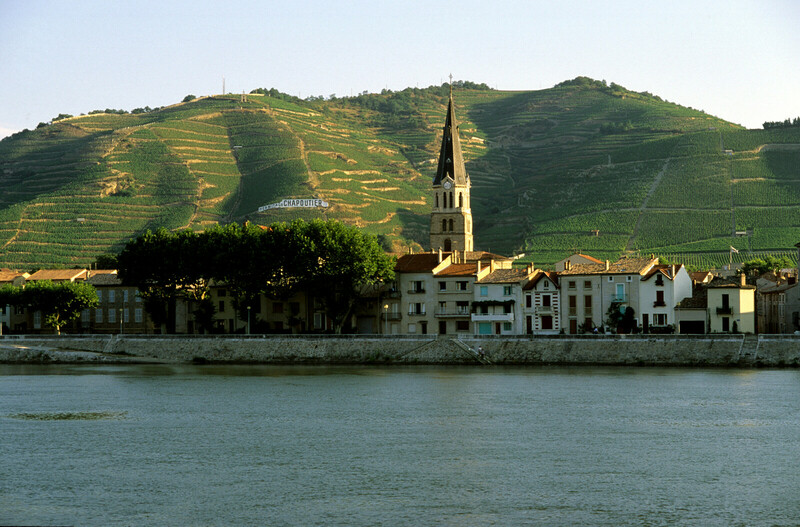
[{"left": 0, "top": 0, "right": 800, "bottom": 137}]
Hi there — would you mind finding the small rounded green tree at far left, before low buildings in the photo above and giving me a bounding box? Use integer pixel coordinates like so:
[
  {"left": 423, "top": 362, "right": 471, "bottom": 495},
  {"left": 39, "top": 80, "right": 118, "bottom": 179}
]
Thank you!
[{"left": 17, "top": 280, "right": 98, "bottom": 335}]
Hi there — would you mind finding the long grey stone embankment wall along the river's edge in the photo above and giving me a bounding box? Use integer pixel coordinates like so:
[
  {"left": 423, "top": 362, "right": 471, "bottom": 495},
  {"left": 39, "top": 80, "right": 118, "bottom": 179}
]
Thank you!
[{"left": 0, "top": 335, "right": 800, "bottom": 367}]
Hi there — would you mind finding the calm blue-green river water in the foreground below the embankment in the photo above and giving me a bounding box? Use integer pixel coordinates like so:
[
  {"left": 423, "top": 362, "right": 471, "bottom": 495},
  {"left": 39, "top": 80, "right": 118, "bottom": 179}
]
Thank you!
[{"left": 0, "top": 365, "right": 800, "bottom": 526}]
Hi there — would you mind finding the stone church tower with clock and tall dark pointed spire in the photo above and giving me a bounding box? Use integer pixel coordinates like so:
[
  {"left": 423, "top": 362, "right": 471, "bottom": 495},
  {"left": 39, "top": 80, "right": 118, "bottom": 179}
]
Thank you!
[{"left": 430, "top": 84, "right": 474, "bottom": 251}]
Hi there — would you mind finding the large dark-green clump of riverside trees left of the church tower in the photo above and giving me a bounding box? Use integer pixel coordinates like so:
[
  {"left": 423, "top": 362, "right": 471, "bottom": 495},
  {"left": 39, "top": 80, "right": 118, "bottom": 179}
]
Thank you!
[{"left": 117, "top": 220, "right": 394, "bottom": 332}]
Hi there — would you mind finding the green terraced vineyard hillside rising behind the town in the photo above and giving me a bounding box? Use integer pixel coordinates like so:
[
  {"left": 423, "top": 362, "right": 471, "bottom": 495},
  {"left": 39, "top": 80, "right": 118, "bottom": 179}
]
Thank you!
[{"left": 0, "top": 78, "right": 800, "bottom": 269}]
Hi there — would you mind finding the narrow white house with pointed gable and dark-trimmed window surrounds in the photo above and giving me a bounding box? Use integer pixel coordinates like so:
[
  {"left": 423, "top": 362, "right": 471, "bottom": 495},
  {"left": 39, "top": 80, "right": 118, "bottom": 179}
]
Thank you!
[{"left": 522, "top": 270, "right": 562, "bottom": 335}]
